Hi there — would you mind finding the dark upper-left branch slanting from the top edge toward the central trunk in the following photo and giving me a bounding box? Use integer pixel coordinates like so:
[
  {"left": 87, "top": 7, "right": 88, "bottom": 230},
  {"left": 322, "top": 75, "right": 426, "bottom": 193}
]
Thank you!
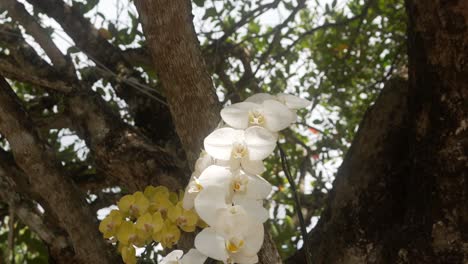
[{"left": 28, "top": 0, "right": 178, "bottom": 142}]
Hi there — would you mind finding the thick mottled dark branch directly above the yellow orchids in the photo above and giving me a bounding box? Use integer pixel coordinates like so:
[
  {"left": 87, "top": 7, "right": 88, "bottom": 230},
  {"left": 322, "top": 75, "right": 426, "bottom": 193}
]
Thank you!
[{"left": 0, "top": 27, "right": 188, "bottom": 191}]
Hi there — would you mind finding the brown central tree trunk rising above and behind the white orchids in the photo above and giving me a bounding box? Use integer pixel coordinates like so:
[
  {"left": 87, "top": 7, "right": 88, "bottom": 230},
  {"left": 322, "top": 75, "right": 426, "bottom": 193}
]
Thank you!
[{"left": 135, "top": 0, "right": 220, "bottom": 166}]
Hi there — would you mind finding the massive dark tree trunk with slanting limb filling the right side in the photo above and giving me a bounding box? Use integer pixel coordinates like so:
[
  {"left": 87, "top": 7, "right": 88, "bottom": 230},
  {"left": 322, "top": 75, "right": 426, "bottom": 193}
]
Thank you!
[{"left": 289, "top": 0, "right": 468, "bottom": 264}]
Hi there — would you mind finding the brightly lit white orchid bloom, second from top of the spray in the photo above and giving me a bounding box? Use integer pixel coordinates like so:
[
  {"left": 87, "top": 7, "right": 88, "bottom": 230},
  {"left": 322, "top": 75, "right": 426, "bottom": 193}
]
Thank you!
[{"left": 204, "top": 126, "right": 276, "bottom": 174}]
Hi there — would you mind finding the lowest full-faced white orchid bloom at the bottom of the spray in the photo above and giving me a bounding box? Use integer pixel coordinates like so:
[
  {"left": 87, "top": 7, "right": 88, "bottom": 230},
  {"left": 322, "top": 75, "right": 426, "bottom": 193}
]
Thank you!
[{"left": 195, "top": 206, "right": 264, "bottom": 264}]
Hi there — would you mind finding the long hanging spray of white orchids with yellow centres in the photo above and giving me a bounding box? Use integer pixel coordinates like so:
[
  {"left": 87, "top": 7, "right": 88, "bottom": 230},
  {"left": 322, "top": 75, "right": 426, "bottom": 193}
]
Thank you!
[{"left": 162, "top": 93, "right": 310, "bottom": 264}]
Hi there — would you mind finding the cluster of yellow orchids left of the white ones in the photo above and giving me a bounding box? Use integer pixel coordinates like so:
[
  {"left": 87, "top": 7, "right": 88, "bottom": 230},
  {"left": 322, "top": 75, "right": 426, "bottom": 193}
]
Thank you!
[{"left": 99, "top": 186, "right": 206, "bottom": 264}]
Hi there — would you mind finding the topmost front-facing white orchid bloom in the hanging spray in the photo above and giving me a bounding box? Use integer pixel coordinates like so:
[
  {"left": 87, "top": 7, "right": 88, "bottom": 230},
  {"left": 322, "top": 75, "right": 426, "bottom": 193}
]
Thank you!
[{"left": 221, "top": 100, "right": 296, "bottom": 132}]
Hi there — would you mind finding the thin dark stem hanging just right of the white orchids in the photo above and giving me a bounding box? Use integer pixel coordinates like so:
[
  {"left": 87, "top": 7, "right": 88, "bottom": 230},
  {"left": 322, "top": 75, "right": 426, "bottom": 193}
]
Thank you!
[{"left": 278, "top": 143, "right": 312, "bottom": 264}]
